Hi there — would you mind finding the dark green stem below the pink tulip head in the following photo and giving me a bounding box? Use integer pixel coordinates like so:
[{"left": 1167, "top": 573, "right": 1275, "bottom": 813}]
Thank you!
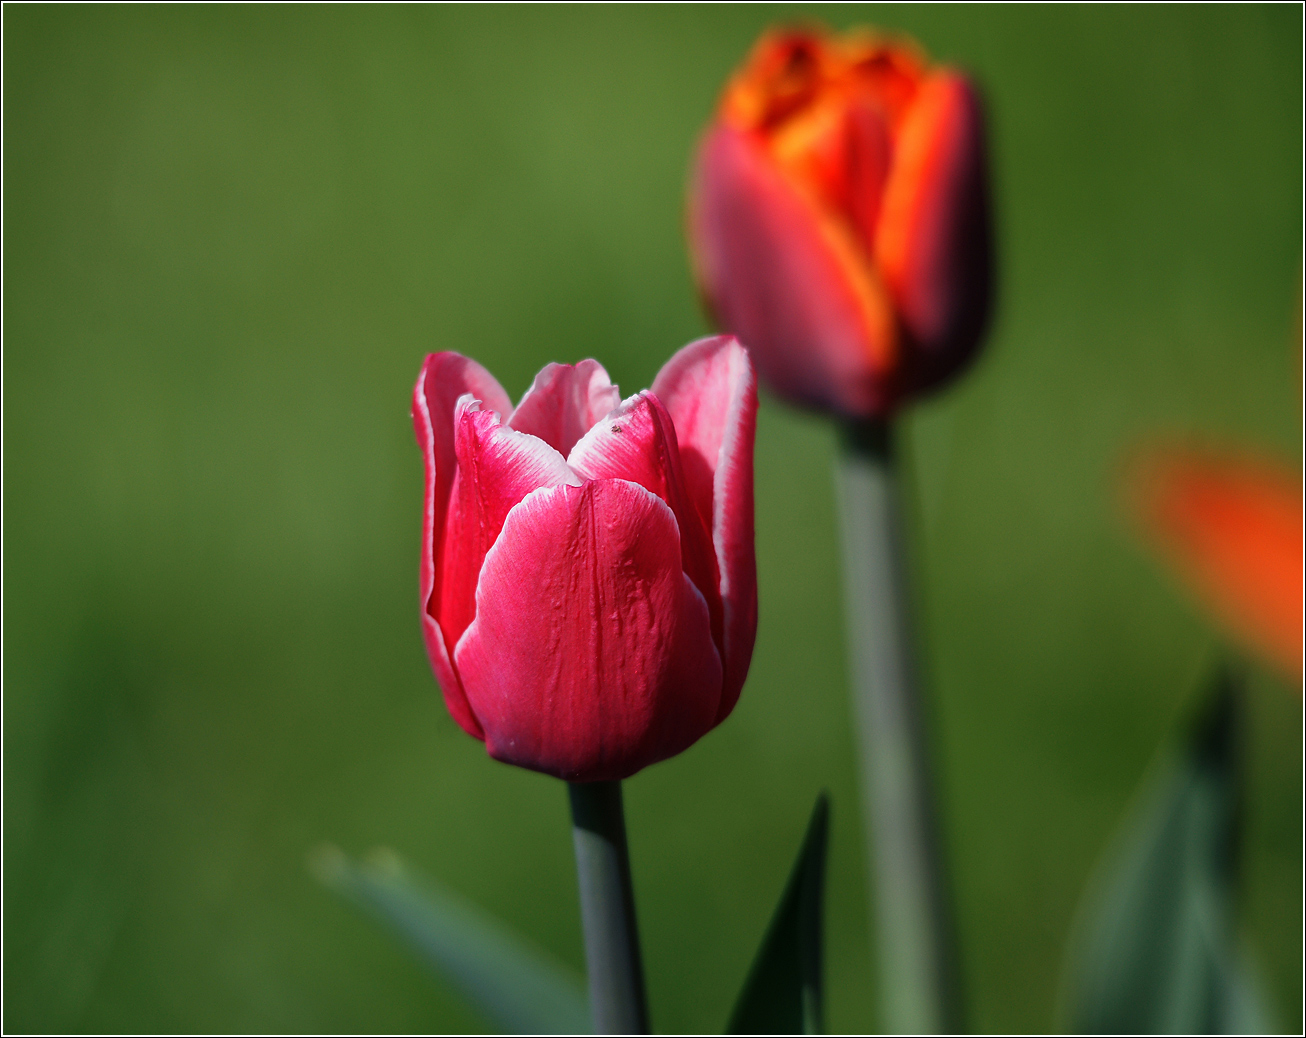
[{"left": 567, "top": 782, "right": 649, "bottom": 1034}]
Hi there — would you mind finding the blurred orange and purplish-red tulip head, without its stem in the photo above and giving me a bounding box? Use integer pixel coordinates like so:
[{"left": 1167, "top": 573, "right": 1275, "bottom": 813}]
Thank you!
[{"left": 690, "top": 30, "right": 991, "bottom": 418}]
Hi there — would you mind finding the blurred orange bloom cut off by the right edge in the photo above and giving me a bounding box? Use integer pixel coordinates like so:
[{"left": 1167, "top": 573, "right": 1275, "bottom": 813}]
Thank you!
[{"left": 1135, "top": 449, "right": 1302, "bottom": 680}]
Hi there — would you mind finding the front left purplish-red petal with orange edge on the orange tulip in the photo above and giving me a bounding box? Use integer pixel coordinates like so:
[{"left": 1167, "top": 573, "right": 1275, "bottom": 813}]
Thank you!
[{"left": 690, "top": 124, "right": 897, "bottom": 415}]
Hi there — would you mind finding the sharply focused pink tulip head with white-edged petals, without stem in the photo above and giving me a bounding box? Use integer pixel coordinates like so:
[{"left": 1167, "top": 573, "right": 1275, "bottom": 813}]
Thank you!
[{"left": 413, "top": 337, "right": 757, "bottom": 782}]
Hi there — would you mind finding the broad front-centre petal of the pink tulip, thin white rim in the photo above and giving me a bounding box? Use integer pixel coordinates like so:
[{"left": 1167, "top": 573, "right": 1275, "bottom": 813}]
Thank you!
[{"left": 454, "top": 479, "right": 721, "bottom": 782}]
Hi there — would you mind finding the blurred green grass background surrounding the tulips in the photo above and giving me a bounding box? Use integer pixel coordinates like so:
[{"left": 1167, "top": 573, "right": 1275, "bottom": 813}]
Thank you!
[{"left": 4, "top": 7, "right": 1302, "bottom": 1031}]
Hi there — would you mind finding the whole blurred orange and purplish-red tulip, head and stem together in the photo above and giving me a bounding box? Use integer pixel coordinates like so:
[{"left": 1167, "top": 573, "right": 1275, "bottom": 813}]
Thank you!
[{"left": 688, "top": 29, "right": 991, "bottom": 1033}]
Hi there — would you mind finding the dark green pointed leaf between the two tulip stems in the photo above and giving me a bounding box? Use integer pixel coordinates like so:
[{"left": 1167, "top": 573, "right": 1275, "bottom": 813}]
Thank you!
[{"left": 726, "top": 793, "right": 829, "bottom": 1034}]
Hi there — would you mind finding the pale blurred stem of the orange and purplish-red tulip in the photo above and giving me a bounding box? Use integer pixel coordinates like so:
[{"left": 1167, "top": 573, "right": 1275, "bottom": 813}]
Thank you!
[{"left": 837, "top": 420, "right": 961, "bottom": 1034}]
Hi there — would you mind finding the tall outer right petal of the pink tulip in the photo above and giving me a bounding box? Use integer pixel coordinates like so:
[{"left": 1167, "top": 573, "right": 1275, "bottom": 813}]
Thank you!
[{"left": 653, "top": 336, "right": 757, "bottom": 722}]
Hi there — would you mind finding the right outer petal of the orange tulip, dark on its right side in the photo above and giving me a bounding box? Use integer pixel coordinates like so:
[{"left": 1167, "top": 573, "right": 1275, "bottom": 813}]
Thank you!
[{"left": 875, "top": 71, "right": 991, "bottom": 390}]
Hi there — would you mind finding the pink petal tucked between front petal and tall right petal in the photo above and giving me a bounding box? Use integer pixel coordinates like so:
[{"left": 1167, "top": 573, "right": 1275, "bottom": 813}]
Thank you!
[{"left": 567, "top": 390, "right": 724, "bottom": 650}]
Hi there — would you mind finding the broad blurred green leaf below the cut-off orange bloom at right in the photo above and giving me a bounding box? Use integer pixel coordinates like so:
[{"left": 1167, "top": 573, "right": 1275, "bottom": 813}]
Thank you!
[{"left": 1062, "top": 671, "right": 1268, "bottom": 1034}]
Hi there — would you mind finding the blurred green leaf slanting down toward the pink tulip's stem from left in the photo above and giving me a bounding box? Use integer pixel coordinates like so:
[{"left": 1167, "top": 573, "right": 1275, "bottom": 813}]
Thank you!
[{"left": 311, "top": 847, "right": 590, "bottom": 1034}]
